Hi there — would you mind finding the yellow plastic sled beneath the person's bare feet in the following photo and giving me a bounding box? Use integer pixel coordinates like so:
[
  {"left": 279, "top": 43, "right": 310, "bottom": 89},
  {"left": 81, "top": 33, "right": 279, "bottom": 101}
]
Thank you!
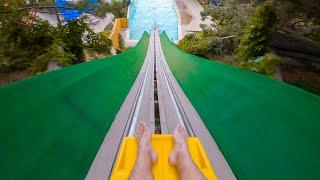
[{"left": 111, "top": 134, "right": 217, "bottom": 180}]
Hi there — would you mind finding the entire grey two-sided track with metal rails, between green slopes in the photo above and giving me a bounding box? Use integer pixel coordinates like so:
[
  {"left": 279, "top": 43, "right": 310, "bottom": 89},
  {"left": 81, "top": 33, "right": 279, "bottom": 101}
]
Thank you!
[{"left": 86, "top": 28, "right": 234, "bottom": 179}]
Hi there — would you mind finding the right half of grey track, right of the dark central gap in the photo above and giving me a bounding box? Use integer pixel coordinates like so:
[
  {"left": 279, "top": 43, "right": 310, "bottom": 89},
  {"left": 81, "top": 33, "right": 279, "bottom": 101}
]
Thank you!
[{"left": 154, "top": 30, "right": 235, "bottom": 180}]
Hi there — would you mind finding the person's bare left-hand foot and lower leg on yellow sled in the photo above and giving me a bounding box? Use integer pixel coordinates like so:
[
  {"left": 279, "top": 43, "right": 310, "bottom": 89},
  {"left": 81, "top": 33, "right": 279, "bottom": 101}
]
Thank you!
[{"left": 129, "top": 122, "right": 157, "bottom": 180}]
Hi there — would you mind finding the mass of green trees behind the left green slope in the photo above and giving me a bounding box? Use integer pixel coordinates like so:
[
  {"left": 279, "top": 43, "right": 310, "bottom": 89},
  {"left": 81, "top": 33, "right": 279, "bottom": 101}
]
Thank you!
[{"left": 0, "top": 0, "right": 115, "bottom": 73}]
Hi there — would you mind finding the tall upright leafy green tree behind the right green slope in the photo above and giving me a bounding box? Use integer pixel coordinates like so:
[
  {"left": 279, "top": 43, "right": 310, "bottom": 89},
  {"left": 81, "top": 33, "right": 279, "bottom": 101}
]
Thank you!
[{"left": 237, "top": 3, "right": 277, "bottom": 61}]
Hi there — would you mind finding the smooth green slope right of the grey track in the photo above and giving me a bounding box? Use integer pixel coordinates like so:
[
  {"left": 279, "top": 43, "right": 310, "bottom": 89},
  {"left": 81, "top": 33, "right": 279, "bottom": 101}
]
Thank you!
[{"left": 161, "top": 33, "right": 320, "bottom": 180}]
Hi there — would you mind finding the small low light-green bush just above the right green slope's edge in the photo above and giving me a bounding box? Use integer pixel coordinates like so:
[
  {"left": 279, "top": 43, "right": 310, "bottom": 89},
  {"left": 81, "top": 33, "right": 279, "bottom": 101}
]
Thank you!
[{"left": 241, "top": 53, "right": 282, "bottom": 76}]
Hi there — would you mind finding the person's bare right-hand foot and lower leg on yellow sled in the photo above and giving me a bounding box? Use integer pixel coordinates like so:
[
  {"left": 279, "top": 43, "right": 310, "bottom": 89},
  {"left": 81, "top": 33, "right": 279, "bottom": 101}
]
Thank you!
[{"left": 169, "top": 124, "right": 205, "bottom": 180}]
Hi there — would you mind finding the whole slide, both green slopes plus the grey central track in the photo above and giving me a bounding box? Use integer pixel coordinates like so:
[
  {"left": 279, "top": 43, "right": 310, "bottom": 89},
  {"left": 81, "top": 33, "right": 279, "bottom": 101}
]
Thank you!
[{"left": 0, "top": 31, "right": 320, "bottom": 179}]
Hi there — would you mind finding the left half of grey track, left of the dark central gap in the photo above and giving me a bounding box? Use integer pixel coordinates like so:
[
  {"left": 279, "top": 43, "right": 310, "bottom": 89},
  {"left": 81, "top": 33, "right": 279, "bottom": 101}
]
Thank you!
[{"left": 86, "top": 31, "right": 155, "bottom": 180}]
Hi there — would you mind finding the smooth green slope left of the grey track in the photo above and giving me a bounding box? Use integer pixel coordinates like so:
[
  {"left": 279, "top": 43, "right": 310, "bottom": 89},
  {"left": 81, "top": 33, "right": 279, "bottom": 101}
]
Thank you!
[{"left": 0, "top": 33, "right": 149, "bottom": 179}]
